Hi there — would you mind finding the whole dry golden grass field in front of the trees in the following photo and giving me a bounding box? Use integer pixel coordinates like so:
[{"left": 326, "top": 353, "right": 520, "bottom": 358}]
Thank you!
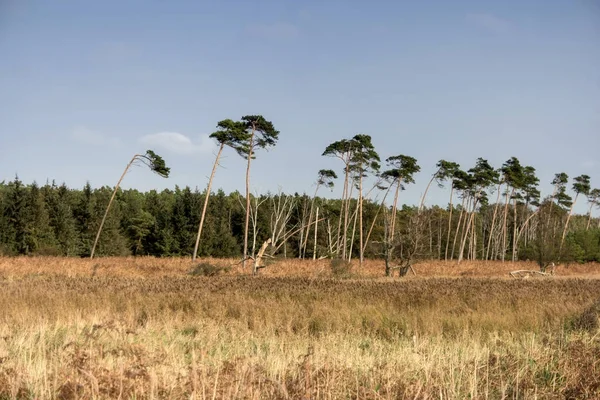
[{"left": 0, "top": 257, "right": 600, "bottom": 399}]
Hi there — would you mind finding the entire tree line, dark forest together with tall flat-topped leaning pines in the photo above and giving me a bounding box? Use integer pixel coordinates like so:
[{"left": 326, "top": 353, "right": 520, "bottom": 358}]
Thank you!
[{"left": 0, "top": 115, "right": 600, "bottom": 274}]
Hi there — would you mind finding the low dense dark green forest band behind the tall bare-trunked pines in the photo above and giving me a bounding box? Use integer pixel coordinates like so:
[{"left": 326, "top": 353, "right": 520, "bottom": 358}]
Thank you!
[{"left": 0, "top": 177, "right": 600, "bottom": 263}]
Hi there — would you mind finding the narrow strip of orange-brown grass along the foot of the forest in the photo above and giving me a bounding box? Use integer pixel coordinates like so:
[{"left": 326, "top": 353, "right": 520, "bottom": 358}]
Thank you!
[{"left": 0, "top": 257, "right": 600, "bottom": 278}]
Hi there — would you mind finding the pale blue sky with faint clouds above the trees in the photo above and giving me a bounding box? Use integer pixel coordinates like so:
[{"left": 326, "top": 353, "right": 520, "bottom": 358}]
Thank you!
[{"left": 0, "top": 0, "right": 600, "bottom": 212}]
